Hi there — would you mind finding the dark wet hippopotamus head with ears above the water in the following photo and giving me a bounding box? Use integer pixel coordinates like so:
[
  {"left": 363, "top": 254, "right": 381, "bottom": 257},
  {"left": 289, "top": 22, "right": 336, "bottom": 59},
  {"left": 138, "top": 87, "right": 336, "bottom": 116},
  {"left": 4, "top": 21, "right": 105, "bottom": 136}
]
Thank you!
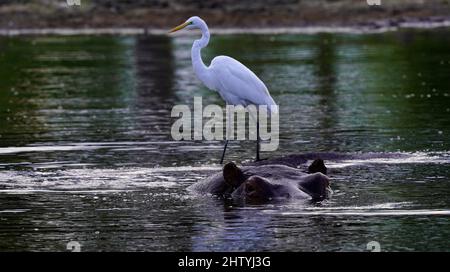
[{"left": 189, "top": 159, "right": 331, "bottom": 203}]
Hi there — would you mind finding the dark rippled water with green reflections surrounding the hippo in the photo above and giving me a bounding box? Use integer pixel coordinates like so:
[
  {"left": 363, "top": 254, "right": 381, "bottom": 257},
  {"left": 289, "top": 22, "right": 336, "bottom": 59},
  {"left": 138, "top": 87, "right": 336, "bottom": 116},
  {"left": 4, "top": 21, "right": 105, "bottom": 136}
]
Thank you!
[{"left": 0, "top": 29, "right": 450, "bottom": 251}]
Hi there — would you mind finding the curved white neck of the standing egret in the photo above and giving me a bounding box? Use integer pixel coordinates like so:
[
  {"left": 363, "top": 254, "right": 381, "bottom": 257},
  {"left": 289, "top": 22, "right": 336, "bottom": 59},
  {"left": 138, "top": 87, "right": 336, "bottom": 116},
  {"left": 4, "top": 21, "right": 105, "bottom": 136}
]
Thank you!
[{"left": 191, "top": 23, "right": 211, "bottom": 88}]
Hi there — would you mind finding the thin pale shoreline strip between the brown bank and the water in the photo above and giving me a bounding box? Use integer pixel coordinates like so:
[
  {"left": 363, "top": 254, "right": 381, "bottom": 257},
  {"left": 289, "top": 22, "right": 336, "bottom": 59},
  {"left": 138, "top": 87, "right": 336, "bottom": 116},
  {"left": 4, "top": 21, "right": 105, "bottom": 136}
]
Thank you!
[{"left": 0, "top": 18, "right": 450, "bottom": 37}]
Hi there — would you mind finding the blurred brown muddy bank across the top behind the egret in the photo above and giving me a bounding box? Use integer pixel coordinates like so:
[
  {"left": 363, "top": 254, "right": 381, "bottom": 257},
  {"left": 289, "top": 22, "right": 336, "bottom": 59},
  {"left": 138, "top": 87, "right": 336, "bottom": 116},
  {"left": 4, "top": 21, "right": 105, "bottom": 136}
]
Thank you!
[{"left": 0, "top": 0, "right": 450, "bottom": 31}]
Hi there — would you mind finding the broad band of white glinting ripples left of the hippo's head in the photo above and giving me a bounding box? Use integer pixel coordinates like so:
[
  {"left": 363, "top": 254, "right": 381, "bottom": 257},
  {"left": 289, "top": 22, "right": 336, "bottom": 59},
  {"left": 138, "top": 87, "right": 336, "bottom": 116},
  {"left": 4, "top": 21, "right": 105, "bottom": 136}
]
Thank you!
[{"left": 0, "top": 166, "right": 219, "bottom": 194}]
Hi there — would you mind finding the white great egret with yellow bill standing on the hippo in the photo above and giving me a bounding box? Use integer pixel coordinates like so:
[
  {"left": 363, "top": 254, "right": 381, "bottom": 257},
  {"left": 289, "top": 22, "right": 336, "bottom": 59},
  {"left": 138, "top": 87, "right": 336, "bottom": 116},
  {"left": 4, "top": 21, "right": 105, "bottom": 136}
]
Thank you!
[{"left": 169, "top": 16, "right": 278, "bottom": 164}]
